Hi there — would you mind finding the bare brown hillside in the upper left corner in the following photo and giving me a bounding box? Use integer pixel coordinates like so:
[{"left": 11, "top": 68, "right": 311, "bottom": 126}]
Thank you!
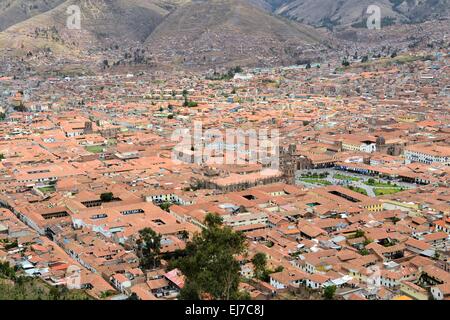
[{"left": 0, "top": 0, "right": 169, "bottom": 56}]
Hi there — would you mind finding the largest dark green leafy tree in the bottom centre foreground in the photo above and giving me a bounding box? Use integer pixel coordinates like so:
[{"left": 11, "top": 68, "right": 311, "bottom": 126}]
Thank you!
[{"left": 174, "top": 213, "right": 245, "bottom": 300}]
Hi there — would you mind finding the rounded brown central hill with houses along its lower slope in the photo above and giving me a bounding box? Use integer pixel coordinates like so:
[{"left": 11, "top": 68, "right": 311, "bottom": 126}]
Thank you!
[{"left": 146, "top": 0, "right": 325, "bottom": 67}]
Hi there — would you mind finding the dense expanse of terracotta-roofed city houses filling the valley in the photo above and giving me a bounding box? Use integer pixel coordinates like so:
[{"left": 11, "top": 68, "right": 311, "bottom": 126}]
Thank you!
[{"left": 0, "top": 46, "right": 450, "bottom": 300}]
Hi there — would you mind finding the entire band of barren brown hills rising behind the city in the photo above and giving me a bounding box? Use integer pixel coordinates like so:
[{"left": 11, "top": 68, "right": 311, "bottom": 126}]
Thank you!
[{"left": 0, "top": 0, "right": 444, "bottom": 68}]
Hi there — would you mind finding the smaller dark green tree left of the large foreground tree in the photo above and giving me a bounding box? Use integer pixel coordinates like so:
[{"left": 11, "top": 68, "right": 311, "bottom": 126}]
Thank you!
[{"left": 136, "top": 228, "right": 162, "bottom": 269}]
